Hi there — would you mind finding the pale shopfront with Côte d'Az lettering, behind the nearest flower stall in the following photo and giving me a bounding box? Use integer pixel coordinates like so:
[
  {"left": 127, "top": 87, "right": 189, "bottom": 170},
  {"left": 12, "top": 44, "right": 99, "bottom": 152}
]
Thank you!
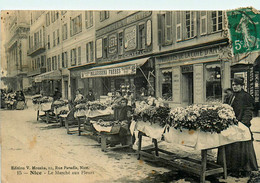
[{"left": 156, "top": 45, "right": 230, "bottom": 106}]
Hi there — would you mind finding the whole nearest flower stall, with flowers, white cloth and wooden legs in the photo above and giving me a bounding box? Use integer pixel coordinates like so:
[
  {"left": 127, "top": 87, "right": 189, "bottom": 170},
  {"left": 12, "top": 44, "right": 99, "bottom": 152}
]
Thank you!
[{"left": 130, "top": 99, "right": 251, "bottom": 182}]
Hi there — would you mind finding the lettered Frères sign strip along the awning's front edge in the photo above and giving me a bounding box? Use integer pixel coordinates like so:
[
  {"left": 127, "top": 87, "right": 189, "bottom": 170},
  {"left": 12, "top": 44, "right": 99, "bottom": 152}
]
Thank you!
[{"left": 81, "top": 64, "right": 136, "bottom": 78}]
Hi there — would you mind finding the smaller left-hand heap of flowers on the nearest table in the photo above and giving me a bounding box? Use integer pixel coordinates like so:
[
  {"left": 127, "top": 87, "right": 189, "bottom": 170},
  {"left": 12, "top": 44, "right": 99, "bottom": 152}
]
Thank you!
[{"left": 134, "top": 97, "right": 170, "bottom": 127}]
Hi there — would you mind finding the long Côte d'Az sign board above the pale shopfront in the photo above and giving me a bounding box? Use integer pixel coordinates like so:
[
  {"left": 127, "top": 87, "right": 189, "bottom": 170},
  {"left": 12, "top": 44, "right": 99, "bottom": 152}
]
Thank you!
[{"left": 160, "top": 47, "right": 221, "bottom": 63}]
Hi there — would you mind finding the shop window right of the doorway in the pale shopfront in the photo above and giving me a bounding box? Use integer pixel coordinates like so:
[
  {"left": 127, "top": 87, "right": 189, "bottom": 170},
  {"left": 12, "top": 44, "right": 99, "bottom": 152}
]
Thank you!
[{"left": 205, "top": 64, "right": 222, "bottom": 102}]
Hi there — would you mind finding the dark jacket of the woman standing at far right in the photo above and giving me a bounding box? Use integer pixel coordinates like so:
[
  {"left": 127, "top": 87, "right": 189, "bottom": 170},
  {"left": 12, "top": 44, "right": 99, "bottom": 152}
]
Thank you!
[{"left": 230, "top": 89, "right": 254, "bottom": 127}]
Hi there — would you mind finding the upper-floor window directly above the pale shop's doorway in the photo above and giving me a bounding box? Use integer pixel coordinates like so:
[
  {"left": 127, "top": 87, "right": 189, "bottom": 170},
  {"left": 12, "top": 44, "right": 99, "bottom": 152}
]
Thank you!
[{"left": 185, "top": 11, "right": 196, "bottom": 38}]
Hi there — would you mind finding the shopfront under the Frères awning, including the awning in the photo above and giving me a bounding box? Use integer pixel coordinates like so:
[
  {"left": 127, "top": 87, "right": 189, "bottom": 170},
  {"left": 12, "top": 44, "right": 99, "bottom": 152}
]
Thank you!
[{"left": 81, "top": 58, "right": 155, "bottom": 98}]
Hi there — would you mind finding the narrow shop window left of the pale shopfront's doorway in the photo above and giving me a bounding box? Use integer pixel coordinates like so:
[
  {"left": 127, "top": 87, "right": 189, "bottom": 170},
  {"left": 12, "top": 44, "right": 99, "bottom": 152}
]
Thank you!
[{"left": 162, "top": 71, "right": 172, "bottom": 101}]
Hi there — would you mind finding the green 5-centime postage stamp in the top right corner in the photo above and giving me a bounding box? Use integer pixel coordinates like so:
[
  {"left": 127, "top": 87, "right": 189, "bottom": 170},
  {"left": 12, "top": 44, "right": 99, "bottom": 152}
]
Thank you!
[{"left": 227, "top": 8, "right": 260, "bottom": 54}]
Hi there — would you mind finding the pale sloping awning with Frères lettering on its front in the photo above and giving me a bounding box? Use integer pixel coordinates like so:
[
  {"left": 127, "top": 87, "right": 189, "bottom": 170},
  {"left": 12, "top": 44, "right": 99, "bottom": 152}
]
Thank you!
[{"left": 81, "top": 58, "right": 149, "bottom": 78}]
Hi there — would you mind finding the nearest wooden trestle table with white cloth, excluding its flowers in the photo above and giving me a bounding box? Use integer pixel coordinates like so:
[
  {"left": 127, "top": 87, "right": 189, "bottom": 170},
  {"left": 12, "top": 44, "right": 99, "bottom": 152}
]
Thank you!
[{"left": 133, "top": 123, "right": 251, "bottom": 182}]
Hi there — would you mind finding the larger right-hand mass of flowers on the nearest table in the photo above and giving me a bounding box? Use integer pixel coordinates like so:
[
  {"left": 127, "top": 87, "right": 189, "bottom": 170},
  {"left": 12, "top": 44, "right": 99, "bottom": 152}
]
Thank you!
[{"left": 169, "top": 103, "right": 238, "bottom": 133}]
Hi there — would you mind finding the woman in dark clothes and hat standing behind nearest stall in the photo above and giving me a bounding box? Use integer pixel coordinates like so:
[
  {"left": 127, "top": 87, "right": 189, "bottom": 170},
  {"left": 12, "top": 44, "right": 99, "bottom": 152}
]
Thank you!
[{"left": 217, "top": 77, "right": 258, "bottom": 177}]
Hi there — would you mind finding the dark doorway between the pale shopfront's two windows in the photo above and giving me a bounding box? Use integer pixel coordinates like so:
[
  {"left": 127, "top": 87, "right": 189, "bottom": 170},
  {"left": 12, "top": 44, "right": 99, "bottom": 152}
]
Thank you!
[{"left": 182, "top": 72, "right": 193, "bottom": 105}]
